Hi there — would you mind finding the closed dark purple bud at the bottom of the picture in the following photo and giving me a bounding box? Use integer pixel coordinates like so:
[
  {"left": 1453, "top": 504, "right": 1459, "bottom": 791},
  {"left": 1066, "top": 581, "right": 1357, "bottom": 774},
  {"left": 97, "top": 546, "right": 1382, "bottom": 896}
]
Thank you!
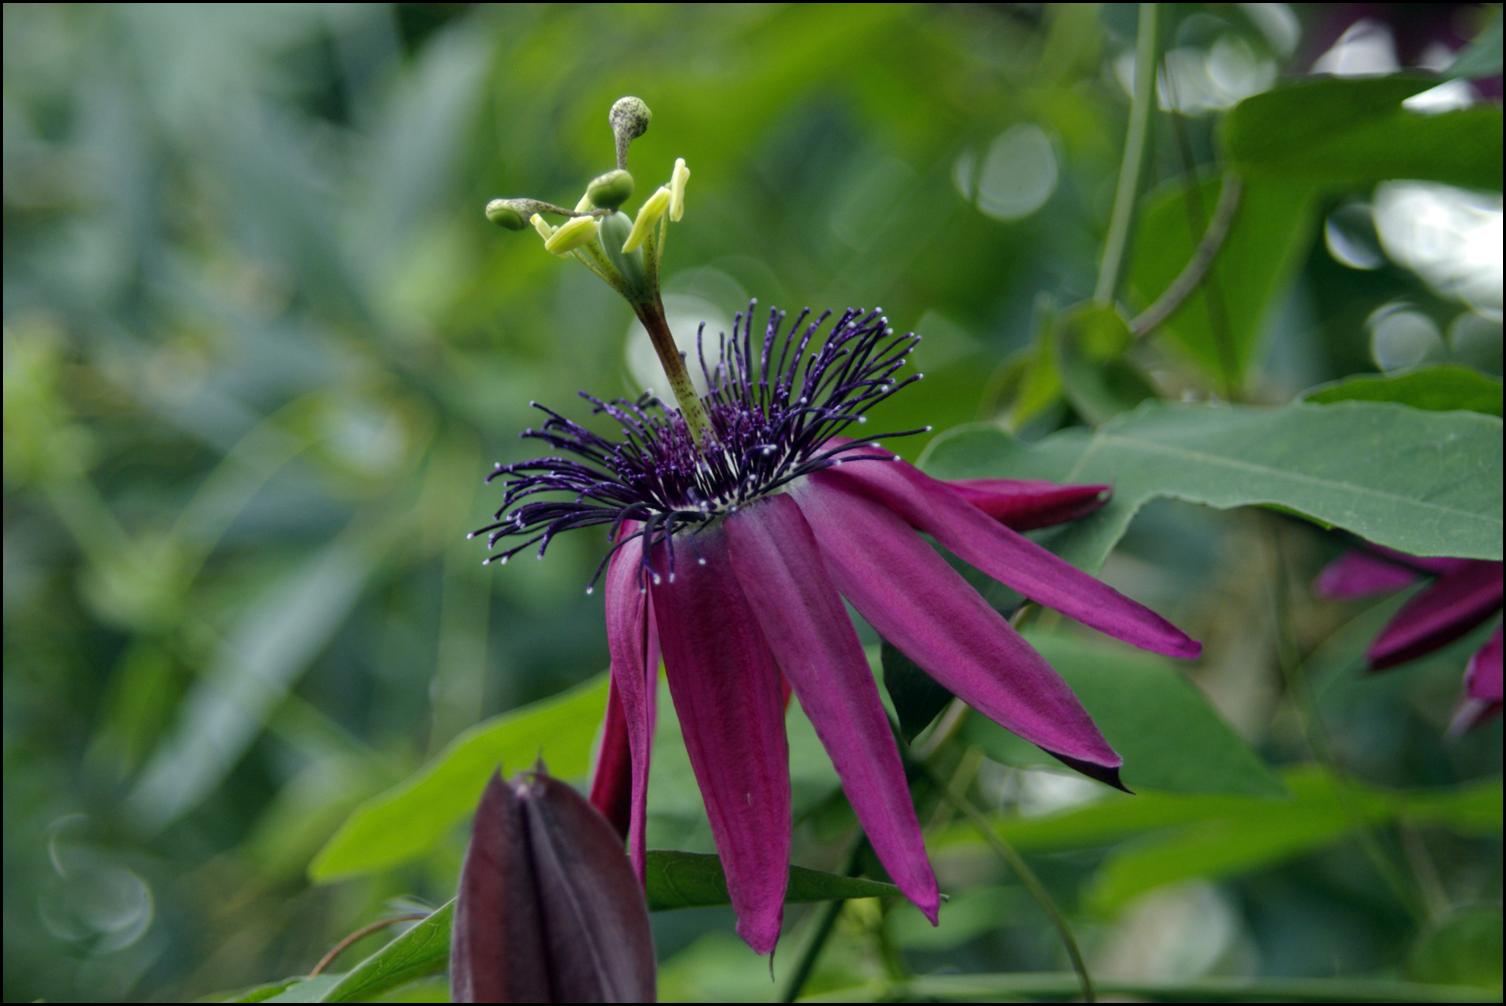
[{"left": 450, "top": 767, "right": 655, "bottom": 1003}]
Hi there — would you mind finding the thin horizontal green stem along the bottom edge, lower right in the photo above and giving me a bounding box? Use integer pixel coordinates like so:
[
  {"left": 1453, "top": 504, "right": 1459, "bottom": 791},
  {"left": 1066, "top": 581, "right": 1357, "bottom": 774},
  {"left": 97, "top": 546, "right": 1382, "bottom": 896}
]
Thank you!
[{"left": 806, "top": 971, "right": 1501, "bottom": 1003}]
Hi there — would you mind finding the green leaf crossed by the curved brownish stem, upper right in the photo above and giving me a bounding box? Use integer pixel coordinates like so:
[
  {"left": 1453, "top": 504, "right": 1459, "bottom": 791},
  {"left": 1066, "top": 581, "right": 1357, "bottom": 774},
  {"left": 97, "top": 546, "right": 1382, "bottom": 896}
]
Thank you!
[{"left": 1128, "top": 178, "right": 1316, "bottom": 387}]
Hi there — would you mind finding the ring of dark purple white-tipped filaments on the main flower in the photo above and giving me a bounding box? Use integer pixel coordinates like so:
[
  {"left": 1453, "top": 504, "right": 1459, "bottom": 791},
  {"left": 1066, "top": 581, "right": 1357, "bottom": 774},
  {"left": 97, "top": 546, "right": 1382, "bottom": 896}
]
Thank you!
[{"left": 470, "top": 303, "right": 923, "bottom": 592}]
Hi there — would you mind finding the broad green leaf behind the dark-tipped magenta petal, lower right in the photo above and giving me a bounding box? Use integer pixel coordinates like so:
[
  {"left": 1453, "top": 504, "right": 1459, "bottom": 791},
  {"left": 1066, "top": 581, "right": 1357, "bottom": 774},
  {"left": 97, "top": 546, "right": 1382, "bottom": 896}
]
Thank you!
[{"left": 962, "top": 633, "right": 1286, "bottom": 797}]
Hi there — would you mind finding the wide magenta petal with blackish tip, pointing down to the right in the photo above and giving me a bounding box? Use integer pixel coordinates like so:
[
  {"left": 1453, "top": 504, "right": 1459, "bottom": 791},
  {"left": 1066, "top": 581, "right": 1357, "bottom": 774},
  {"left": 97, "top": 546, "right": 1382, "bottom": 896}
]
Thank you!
[{"left": 791, "top": 478, "right": 1122, "bottom": 785}]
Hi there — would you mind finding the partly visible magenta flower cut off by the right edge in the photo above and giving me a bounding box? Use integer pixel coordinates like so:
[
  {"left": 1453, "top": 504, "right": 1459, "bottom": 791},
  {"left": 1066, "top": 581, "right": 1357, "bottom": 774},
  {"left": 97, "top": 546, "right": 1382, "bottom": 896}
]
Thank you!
[{"left": 1315, "top": 545, "right": 1501, "bottom": 733}]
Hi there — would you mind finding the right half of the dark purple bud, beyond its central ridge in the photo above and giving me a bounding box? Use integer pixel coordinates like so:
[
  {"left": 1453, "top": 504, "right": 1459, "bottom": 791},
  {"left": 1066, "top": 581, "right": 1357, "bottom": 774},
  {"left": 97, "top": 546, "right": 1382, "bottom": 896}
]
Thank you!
[{"left": 512, "top": 773, "right": 655, "bottom": 1003}]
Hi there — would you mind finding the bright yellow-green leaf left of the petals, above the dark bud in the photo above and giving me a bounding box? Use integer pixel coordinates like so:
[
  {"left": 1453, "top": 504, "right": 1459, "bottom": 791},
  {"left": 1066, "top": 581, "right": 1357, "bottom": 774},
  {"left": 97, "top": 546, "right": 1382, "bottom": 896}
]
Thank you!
[{"left": 309, "top": 675, "right": 607, "bottom": 883}]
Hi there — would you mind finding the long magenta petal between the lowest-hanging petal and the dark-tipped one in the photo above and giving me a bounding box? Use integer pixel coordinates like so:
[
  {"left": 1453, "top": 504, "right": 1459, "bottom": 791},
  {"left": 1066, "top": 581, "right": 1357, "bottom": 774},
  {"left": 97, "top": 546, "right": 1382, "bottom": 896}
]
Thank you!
[{"left": 726, "top": 495, "right": 940, "bottom": 925}]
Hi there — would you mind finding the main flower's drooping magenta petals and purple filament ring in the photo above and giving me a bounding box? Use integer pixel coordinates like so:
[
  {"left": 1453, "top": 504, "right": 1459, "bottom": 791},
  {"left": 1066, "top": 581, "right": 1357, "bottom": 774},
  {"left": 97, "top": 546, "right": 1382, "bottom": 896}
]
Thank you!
[{"left": 476, "top": 306, "right": 1199, "bottom": 953}]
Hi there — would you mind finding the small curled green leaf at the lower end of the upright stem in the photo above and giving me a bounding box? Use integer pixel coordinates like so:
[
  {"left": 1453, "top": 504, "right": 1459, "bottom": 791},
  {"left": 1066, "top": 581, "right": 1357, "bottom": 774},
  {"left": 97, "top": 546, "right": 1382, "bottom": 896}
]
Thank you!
[{"left": 1051, "top": 304, "right": 1155, "bottom": 426}]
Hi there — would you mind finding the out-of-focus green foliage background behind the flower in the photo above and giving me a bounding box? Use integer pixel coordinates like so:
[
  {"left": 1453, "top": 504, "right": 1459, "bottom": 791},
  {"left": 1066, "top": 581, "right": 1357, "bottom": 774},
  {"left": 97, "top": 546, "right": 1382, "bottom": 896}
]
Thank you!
[{"left": 3, "top": 5, "right": 1501, "bottom": 1000}]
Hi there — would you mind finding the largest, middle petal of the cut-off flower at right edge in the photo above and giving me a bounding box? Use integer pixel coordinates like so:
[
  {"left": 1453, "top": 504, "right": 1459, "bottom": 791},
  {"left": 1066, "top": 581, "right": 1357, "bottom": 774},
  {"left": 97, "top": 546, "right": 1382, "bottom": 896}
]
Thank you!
[{"left": 1367, "top": 560, "right": 1501, "bottom": 670}]
